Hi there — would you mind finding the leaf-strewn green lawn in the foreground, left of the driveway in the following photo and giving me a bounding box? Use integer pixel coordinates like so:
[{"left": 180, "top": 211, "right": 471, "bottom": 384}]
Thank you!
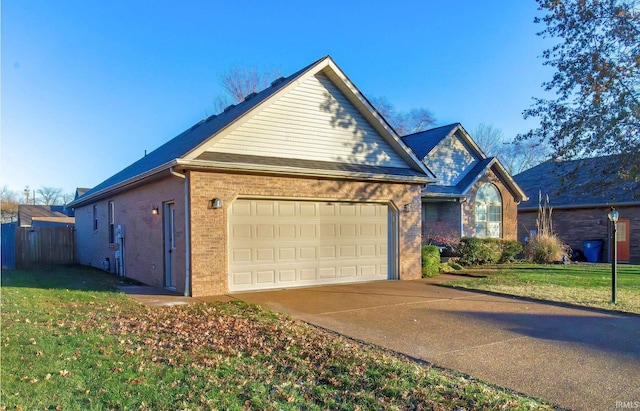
[{"left": 0, "top": 267, "right": 553, "bottom": 410}]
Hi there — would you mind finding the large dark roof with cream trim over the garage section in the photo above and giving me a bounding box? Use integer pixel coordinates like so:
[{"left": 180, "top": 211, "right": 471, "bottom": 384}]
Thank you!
[{"left": 70, "top": 56, "right": 434, "bottom": 207}]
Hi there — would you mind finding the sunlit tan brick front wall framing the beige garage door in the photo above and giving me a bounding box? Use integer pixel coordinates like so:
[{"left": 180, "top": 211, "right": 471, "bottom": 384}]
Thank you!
[{"left": 189, "top": 171, "right": 422, "bottom": 297}]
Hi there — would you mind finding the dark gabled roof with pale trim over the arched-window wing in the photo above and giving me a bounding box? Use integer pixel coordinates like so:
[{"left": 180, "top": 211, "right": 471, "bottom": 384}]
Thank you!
[{"left": 402, "top": 123, "right": 527, "bottom": 202}]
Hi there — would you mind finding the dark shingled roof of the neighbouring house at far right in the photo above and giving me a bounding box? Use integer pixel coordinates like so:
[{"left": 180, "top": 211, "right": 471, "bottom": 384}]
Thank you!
[{"left": 514, "top": 156, "right": 640, "bottom": 210}]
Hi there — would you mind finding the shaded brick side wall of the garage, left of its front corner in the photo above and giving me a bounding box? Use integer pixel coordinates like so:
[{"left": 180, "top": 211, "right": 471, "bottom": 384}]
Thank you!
[{"left": 76, "top": 177, "right": 186, "bottom": 291}]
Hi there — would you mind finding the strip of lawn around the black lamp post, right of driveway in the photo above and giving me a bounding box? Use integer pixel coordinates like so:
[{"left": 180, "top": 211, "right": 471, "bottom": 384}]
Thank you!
[{"left": 442, "top": 264, "right": 640, "bottom": 314}]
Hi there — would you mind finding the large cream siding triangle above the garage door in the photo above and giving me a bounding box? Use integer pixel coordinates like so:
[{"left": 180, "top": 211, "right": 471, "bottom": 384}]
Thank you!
[{"left": 205, "top": 73, "right": 409, "bottom": 168}]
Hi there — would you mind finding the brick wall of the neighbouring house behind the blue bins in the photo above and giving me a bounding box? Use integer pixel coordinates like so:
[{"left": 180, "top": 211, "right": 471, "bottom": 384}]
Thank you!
[{"left": 518, "top": 206, "right": 640, "bottom": 263}]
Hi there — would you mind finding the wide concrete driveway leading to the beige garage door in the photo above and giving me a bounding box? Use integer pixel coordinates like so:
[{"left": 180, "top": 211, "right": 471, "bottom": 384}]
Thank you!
[{"left": 232, "top": 276, "right": 640, "bottom": 410}]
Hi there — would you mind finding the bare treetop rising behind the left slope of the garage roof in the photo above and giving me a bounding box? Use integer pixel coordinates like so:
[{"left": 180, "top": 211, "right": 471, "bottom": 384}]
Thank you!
[{"left": 214, "top": 66, "right": 280, "bottom": 113}]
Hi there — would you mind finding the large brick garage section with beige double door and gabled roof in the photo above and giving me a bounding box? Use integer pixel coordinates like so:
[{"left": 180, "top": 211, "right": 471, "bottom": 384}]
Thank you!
[{"left": 70, "top": 56, "right": 434, "bottom": 296}]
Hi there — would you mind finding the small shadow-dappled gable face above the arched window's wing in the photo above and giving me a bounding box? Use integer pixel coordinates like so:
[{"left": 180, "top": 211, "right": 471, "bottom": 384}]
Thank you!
[{"left": 425, "top": 133, "right": 479, "bottom": 186}]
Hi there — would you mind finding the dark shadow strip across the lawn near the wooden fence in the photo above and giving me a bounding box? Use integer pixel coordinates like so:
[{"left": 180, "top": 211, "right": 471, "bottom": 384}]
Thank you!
[{"left": 2, "top": 265, "right": 140, "bottom": 292}]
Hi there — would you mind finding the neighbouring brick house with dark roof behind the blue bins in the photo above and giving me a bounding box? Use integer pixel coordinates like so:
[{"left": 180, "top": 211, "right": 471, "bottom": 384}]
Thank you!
[{"left": 514, "top": 157, "right": 640, "bottom": 263}]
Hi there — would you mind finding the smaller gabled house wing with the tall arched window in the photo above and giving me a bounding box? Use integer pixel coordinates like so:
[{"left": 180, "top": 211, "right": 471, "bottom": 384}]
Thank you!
[{"left": 402, "top": 123, "right": 527, "bottom": 242}]
